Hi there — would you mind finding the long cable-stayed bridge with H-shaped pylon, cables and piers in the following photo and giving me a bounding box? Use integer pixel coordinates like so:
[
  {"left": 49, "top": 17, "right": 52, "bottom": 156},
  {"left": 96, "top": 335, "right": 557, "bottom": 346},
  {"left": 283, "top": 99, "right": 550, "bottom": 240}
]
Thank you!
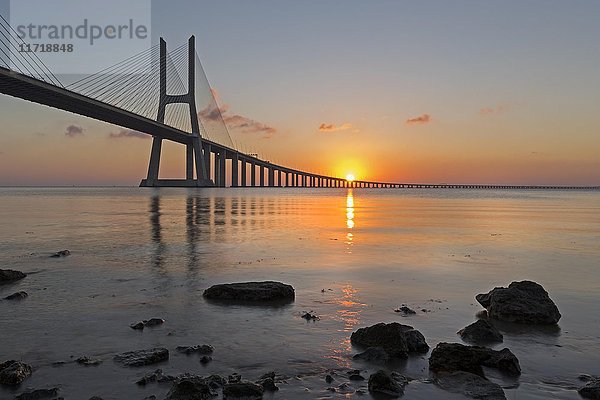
[{"left": 0, "top": 16, "right": 598, "bottom": 189}]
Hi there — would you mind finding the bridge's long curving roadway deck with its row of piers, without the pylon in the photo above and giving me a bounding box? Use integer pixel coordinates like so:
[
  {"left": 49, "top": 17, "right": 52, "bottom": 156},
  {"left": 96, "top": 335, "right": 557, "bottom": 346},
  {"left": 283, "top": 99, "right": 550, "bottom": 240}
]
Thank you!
[{"left": 0, "top": 67, "right": 600, "bottom": 190}]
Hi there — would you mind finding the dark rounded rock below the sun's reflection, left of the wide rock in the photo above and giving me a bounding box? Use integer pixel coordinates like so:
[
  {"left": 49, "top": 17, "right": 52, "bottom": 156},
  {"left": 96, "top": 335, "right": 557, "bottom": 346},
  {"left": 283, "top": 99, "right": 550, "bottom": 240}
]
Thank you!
[{"left": 350, "top": 322, "right": 429, "bottom": 358}]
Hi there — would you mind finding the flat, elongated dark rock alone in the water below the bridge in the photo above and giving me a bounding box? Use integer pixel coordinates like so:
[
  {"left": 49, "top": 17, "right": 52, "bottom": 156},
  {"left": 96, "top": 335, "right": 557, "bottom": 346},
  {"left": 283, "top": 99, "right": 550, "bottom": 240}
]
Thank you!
[{"left": 204, "top": 281, "right": 295, "bottom": 302}]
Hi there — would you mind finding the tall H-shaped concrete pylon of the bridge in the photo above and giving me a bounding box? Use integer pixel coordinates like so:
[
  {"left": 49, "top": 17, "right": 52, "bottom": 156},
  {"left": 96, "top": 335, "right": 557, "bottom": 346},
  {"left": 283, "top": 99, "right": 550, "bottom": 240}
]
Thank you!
[{"left": 140, "top": 35, "right": 214, "bottom": 187}]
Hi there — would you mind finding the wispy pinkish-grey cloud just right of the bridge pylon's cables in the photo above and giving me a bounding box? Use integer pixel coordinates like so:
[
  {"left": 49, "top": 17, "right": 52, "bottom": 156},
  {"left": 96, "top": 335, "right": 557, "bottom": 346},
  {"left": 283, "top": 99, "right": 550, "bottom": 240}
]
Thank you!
[{"left": 198, "top": 89, "right": 277, "bottom": 139}]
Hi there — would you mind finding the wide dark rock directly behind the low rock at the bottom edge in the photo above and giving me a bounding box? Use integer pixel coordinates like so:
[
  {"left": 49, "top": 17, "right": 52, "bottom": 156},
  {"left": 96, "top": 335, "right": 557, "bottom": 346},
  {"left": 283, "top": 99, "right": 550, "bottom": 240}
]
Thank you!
[{"left": 429, "top": 343, "right": 521, "bottom": 377}]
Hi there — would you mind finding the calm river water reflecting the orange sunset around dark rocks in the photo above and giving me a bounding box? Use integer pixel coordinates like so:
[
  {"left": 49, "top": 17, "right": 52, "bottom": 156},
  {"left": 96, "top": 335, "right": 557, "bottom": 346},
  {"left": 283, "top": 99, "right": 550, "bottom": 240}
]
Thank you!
[{"left": 0, "top": 188, "right": 600, "bottom": 400}]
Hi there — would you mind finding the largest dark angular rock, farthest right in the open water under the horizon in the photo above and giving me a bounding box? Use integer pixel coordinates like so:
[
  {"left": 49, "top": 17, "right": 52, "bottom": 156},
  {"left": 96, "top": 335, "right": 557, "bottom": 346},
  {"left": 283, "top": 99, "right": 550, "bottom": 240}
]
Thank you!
[{"left": 475, "top": 281, "right": 561, "bottom": 325}]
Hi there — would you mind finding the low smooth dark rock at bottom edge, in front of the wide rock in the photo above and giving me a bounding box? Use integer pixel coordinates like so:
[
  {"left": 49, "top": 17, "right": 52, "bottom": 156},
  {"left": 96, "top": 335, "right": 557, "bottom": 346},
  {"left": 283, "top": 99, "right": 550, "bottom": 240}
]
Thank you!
[{"left": 434, "top": 371, "right": 506, "bottom": 400}]
